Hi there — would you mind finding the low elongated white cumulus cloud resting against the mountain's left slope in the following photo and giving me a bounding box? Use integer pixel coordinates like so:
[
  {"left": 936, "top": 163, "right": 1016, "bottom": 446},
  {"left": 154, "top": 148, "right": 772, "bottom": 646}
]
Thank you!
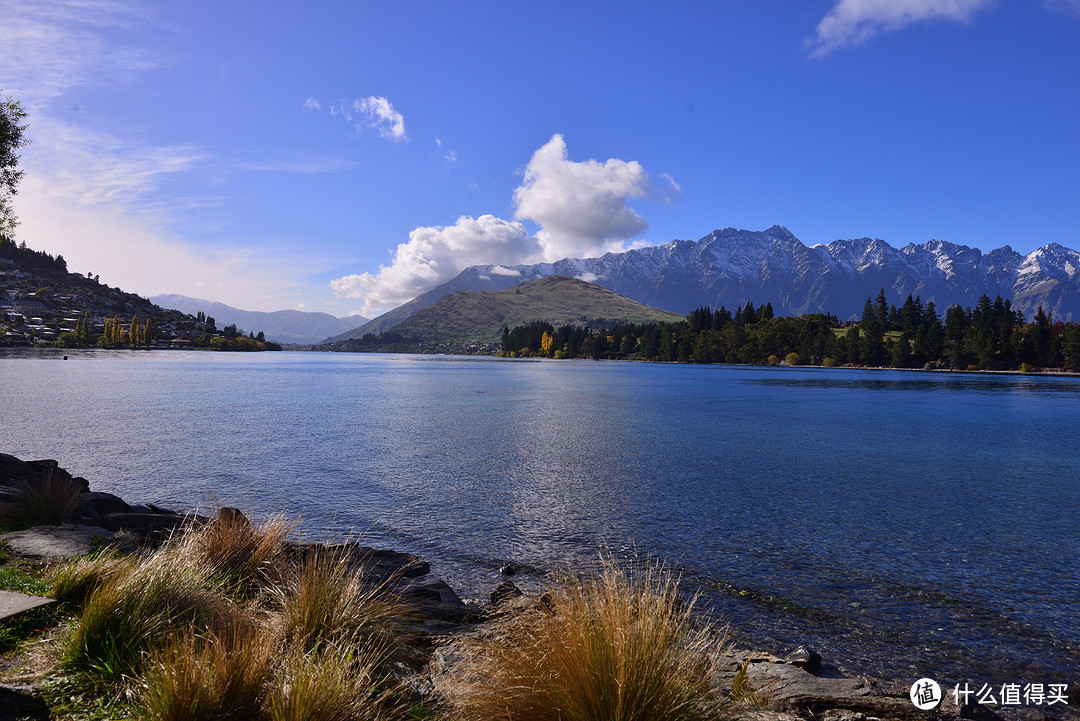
[{"left": 330, "top": 215, "right": 540, "bottom": 316}]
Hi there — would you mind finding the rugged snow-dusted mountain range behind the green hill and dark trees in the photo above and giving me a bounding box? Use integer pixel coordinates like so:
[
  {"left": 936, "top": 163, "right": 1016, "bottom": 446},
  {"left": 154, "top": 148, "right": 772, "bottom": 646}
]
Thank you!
[{"left": 338, "top": 226, "right": 1080, "bottom": 339}]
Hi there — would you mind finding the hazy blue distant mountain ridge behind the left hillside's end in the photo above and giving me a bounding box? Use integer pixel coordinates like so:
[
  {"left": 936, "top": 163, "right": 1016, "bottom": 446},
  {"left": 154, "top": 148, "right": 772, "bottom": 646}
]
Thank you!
[{"left": 150, "top": 294, "right": 367, "bottom": 345}]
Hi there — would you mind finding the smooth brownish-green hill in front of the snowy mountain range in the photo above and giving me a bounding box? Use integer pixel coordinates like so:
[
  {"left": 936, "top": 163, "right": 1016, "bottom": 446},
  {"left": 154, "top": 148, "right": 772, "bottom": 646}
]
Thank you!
[{"left": 335, "top": 275, "right": 683, "bottom": 351}]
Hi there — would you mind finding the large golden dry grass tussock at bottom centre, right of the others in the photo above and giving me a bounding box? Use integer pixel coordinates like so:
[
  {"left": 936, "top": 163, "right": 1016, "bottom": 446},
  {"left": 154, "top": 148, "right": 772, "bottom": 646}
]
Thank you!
[{"left": 441, "top": 559, "right": 730, "bottom": 721}]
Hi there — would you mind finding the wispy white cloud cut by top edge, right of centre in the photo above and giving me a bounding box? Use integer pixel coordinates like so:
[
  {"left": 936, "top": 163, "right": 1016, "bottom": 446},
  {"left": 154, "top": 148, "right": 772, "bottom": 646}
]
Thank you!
[{"left": 808, "top": 0, "right": 994, "bottom": 57}]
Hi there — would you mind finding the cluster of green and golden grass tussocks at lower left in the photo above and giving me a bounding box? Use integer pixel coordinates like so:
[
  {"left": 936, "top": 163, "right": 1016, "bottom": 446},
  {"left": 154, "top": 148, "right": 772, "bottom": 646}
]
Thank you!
[{"left": 46, "top": 514, "right": 403, "bottom": 721}]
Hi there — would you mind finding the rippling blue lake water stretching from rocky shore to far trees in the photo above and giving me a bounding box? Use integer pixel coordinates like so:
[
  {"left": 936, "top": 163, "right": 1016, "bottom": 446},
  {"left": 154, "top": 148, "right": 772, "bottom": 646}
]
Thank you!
[{"left": 0, "top": 351, "right": 1080, "bottom": 688}]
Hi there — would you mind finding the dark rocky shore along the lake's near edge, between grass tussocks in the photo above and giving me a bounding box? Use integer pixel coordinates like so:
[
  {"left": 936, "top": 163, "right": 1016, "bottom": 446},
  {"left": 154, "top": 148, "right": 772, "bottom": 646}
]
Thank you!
[{"left": 0, "top": 453, "right": 1058, "bottom": 721}]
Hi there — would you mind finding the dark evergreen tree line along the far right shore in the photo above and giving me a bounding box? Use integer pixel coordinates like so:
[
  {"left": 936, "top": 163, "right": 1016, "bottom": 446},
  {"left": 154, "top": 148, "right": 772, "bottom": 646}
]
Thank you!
[{"left": 499, "top": 289, "right": 1080, "bottom": 372}]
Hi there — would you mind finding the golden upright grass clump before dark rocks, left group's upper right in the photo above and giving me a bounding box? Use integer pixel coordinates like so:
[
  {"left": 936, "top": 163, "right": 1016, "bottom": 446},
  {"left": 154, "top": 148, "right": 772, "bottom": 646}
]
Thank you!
[{"left": 275, "top": 552, "right": 404, "bottom": 651}]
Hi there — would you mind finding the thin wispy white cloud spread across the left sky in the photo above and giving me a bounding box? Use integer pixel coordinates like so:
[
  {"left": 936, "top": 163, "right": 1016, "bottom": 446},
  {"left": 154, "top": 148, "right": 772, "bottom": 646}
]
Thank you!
[{"left": 0, "top": 0, "right": 340, "bottom": 310}]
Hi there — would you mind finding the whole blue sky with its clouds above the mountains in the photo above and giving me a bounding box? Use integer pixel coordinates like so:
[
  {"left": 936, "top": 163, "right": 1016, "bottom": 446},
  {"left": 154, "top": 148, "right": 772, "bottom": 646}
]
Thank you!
[{"left": 0, "top": 0, "right": 1080, "bottom": 316}]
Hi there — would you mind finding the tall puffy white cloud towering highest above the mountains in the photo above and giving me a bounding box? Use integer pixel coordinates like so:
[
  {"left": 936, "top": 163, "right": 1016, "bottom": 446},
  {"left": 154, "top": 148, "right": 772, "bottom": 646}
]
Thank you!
[{"left": 514, "top": 135, "right": 649, "bottom": 260}]
